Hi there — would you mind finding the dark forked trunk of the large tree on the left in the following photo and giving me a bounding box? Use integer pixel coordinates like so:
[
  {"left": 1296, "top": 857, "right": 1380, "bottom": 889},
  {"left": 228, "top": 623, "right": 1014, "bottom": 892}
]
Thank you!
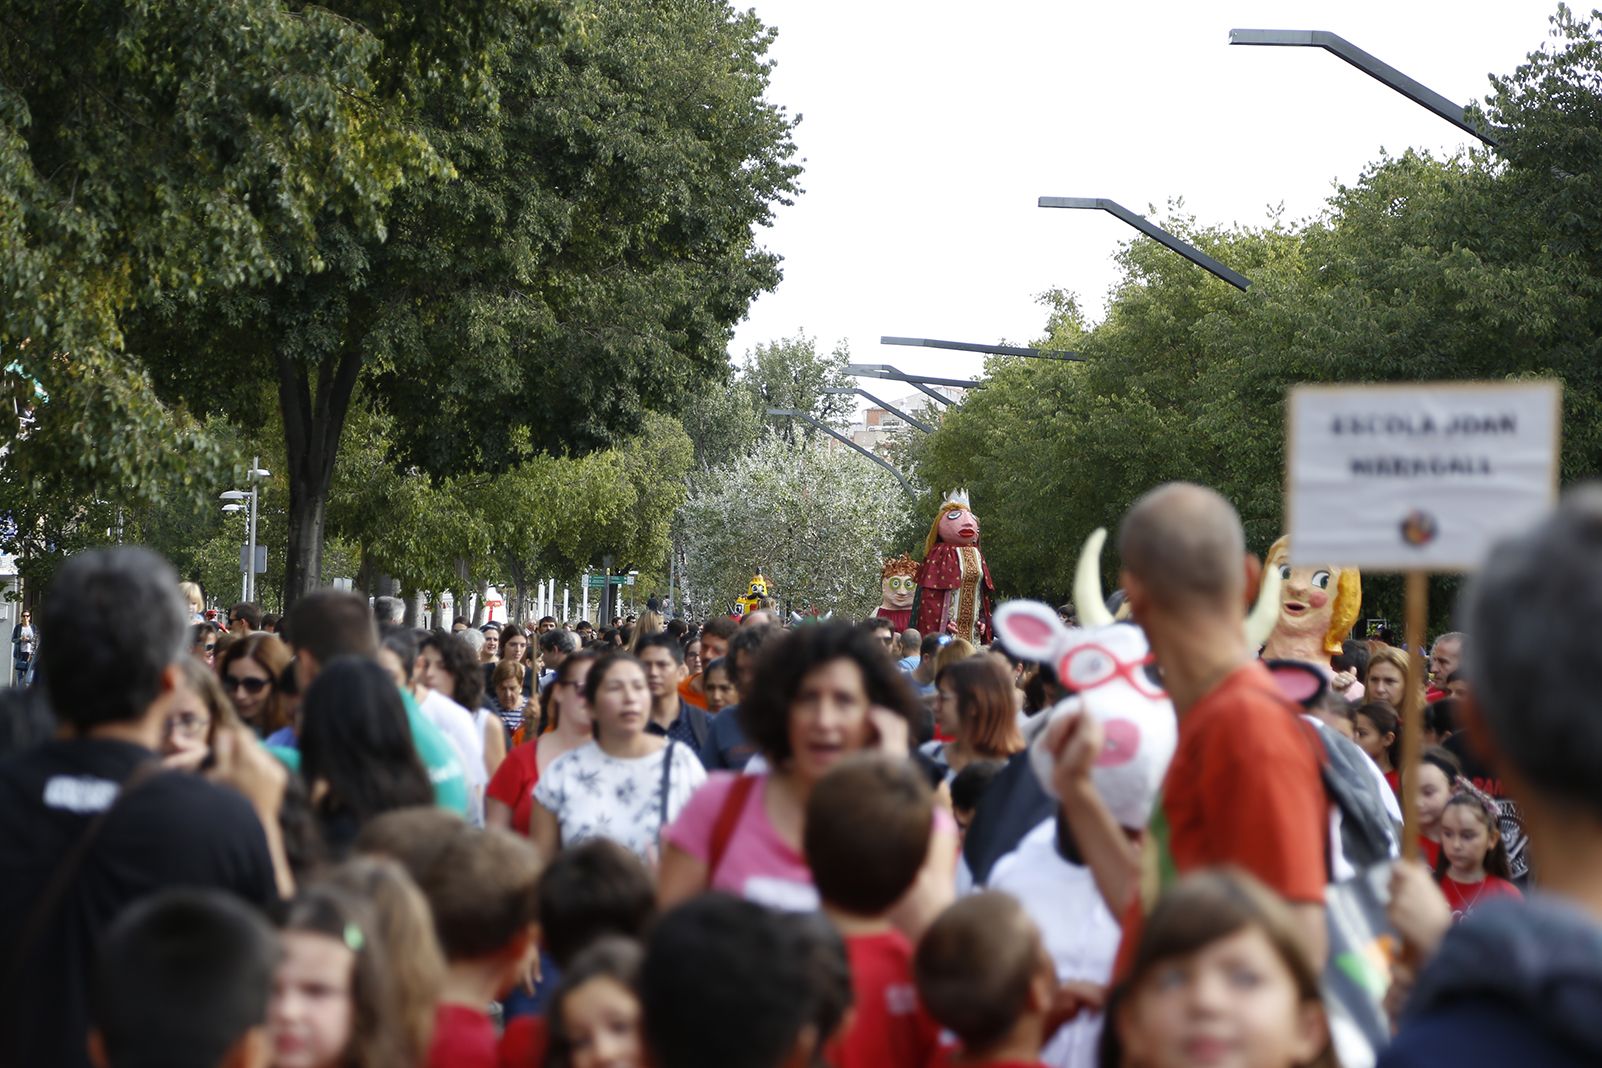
[{"left": 277, "top": 342, "right": 362, "bottom": 612}]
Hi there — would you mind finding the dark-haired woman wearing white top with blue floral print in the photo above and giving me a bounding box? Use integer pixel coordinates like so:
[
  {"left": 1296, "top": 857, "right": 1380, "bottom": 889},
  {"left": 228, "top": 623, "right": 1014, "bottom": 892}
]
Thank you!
[{"left": 530, "top": 653, "right": 706, "bottom": 863}]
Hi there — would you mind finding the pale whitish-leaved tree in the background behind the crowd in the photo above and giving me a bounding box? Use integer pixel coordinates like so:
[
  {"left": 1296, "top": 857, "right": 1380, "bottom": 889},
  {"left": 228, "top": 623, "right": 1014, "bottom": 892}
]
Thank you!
[{"left": 679, "top": 434, "right": 907, "bottom": 618}]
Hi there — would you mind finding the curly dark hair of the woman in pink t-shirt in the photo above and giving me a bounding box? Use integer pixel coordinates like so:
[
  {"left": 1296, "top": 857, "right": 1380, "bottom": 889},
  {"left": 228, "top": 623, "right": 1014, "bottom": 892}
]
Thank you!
[{"left": 733, "top": 623, "right": 923, "bottom": 769}]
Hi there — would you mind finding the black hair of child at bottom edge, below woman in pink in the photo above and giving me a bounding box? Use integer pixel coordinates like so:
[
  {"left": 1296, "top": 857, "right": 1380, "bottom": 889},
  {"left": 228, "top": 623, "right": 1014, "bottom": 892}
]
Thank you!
[{"left": 639, "top": 893, "right": 851, "bottom": 1068}]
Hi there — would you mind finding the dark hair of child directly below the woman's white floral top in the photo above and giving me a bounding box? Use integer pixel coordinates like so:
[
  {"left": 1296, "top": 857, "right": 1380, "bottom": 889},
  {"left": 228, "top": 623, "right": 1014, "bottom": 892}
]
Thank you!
[{"left": 538, "top": 837, "right": 657, "bottom": 972}]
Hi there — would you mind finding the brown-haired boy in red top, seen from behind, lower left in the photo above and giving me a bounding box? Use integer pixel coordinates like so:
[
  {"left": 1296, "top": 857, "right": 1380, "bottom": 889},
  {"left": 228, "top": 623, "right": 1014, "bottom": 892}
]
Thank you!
[{"left": 382, "top": 821, "right": 540, "bottom": 1068}]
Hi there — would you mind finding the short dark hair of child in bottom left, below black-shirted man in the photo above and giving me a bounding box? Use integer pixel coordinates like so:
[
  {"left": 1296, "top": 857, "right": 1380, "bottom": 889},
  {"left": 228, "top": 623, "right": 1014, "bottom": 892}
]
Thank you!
[{"left": 90, "top": 887, "right": 279, "bottom": 1068}]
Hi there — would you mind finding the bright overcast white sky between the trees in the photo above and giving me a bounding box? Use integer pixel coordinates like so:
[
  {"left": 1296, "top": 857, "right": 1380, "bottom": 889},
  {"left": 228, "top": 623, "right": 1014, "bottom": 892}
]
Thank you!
[{"left": 731, "top": 0, "right": 1569, "bottom": 387}]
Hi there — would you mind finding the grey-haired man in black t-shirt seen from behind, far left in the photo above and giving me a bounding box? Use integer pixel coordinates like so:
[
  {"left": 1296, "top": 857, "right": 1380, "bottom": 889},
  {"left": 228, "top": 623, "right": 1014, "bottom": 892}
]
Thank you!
[{"left": 0, "top": 548, "right": 283, "bottom": 1068}]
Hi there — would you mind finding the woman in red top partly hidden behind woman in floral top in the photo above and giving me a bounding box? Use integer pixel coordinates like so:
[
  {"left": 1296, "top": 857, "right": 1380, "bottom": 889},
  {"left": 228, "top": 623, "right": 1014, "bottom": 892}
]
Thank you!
[{"left": 484, "top": 650, "right": 598, "bottom": 834}]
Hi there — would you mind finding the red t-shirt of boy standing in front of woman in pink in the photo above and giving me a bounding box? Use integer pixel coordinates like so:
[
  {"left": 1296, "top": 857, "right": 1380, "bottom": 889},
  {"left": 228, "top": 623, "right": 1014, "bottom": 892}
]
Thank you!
[{"left": 825, "top": 930, "right": 940, "bottom": 1068}]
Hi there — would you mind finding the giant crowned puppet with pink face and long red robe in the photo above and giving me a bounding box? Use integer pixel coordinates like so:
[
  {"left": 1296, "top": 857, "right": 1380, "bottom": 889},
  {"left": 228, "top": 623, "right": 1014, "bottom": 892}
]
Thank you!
[{"left": 912, "top": 490, "right": 995, "bottom": 644}]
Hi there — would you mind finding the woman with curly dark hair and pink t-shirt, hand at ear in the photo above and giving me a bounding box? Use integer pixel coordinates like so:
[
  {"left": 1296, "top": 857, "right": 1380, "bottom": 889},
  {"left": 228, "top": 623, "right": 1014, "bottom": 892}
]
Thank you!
[{"left": 658, "top": 623, "right": 956, "bottom": 929}]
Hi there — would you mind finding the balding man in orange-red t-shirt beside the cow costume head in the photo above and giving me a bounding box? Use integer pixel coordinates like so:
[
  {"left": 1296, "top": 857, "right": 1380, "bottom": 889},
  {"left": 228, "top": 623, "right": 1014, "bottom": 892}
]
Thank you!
[{"left": 1046, "top": 482, "right": 1330, "bottom": 974}]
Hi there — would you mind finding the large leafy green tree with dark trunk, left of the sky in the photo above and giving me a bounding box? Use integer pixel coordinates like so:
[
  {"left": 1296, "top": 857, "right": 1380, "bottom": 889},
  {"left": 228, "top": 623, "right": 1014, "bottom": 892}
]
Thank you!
[{"left": 124, "top": 0, "right": 798, "bottom": 599}]
